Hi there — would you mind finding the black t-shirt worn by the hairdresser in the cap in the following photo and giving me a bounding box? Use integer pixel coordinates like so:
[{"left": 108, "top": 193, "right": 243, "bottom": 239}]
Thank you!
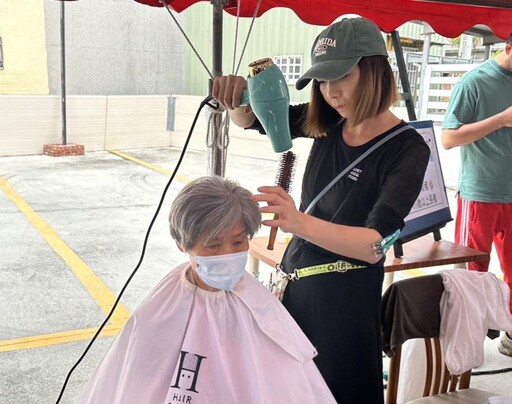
[{"left": 251, "top": 104, "right": 430, "bottom": 272}]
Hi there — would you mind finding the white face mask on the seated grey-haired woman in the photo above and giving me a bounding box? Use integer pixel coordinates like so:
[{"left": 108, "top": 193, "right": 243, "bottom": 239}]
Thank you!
[{"left": 193, "top": 251, "right": 247, "bottom": 290}]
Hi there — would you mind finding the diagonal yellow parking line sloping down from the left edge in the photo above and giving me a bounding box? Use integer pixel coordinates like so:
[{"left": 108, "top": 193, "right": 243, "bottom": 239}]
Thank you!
[{"left": 0, "top": 177, "right": 130, "bottom": 325}]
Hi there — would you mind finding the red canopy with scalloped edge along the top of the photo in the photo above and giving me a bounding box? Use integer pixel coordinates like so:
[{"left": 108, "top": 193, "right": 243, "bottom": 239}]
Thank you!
[{"left": 130, "top": 0, "right": 512, "bottom": 39}]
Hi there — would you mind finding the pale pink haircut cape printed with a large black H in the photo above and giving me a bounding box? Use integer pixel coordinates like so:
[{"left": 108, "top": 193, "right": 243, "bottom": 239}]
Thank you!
[{"left": 78, "top": 264, "right": 336, "bottom": 404}]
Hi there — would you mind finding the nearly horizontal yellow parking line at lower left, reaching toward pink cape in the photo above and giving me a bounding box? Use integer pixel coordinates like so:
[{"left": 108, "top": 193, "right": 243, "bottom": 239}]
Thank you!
[{"left": 0, "top": 324, "right": 122, "bottom": 352}]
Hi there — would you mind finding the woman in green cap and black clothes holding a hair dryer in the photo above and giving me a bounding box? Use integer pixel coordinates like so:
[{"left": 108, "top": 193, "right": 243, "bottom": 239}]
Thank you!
[{"left": 213, "top": 18, "right": 430, "bottom": 404}]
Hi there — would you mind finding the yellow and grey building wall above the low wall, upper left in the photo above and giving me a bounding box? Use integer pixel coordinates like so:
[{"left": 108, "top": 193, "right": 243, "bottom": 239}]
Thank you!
[{"left": 0, "top": 0, "right": 186, "bottom": 95}]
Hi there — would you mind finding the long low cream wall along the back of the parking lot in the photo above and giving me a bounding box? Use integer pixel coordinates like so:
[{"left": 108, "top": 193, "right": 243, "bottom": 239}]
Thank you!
[{"left": 0, "top": 95, "right": 309, "bottom": 159}]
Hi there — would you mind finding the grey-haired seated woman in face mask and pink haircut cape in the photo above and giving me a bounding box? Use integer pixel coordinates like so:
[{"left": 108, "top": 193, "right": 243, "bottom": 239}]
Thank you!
[{"left": 79, "top": 177, "right": 335, "bottom": 404}]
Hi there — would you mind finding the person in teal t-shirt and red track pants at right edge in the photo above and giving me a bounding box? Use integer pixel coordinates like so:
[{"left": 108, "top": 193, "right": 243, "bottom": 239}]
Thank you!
[{"left": 441, "top": 34, "right": 512, "bottom": 356}]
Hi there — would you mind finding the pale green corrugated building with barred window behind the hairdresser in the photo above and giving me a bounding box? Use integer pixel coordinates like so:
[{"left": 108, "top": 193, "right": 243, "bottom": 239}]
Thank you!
[{"left": 183, "top": 2, "right": 449, "bottom": 102}]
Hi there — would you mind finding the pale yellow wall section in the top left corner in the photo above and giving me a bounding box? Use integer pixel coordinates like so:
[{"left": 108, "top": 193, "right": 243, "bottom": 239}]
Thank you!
[{"left": 0, "top": 0, "right": 49, "bottom": 94}]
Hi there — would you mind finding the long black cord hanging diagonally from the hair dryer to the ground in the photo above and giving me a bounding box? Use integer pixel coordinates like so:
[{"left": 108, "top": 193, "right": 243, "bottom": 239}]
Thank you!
[{"left": 55, "top": 95, "right": 218, "bottom": 404}]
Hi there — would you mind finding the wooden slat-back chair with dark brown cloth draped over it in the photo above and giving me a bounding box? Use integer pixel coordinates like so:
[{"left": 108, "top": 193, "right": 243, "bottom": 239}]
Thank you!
[{"left": 382, "top": 274, "right": 499, "bottom": 404}]
